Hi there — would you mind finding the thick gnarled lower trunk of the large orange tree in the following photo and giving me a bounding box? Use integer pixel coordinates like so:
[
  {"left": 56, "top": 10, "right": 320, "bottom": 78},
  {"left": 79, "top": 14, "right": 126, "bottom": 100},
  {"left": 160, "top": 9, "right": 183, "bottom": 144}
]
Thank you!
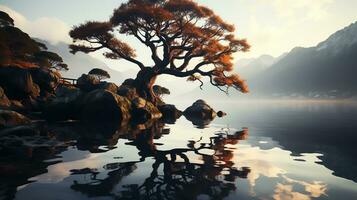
[{"left": 134, "top": 67, "right": 158, "bottom": 105}]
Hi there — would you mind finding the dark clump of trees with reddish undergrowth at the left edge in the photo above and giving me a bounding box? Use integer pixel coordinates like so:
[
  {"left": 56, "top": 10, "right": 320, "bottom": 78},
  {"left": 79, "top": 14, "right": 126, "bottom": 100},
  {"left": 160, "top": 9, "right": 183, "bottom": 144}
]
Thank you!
[{"left": 0, "top": 12, "right": 68, "bottom": 70}]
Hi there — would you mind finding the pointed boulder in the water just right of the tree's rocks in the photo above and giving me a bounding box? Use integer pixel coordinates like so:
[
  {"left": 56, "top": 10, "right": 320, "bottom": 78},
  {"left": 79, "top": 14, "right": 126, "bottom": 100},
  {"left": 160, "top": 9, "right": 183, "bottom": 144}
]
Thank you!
[{"left": 184, "top": 99, "right": 217, "bottom": 119}]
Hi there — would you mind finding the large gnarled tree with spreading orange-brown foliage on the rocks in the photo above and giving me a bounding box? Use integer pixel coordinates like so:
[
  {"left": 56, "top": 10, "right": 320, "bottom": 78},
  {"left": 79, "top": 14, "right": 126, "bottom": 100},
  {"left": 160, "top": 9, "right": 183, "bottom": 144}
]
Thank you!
[{"left": 70, "top": 0, "right": 250, "bottom": 103}]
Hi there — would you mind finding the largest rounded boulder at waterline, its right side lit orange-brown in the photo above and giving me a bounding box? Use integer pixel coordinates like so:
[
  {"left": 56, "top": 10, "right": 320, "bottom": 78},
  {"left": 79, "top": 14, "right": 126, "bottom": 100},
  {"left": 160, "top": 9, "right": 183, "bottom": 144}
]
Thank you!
[{"left": 82, "top": 89, "right": 131, "bottom": 122}]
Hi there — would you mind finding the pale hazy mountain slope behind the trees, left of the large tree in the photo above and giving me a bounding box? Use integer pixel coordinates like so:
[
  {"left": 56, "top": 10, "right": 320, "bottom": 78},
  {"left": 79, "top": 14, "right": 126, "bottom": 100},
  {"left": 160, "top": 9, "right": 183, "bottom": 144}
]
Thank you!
[{"left": 36, "top": 39, "right": 124, "bottom": 84}]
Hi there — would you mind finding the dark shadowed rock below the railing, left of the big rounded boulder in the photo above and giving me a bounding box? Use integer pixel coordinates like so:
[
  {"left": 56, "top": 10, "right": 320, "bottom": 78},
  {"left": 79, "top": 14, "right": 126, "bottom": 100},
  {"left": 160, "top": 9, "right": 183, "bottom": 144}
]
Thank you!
[{"left": 43, "top": 86, "right": 84, "bottom": 121}]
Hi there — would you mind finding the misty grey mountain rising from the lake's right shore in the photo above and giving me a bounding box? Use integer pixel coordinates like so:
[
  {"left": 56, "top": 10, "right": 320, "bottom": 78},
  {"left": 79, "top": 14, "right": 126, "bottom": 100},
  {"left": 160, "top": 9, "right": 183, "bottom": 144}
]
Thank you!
[{"left": 248, "top": 22, "right": 357, "bottom": 98}]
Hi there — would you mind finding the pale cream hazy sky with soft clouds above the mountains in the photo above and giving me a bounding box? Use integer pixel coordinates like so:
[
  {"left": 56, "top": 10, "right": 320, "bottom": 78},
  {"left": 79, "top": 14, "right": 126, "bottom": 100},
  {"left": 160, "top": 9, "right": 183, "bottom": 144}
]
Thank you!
[{"left": 0, "top": 0, "right": 357, "bottom": 67}]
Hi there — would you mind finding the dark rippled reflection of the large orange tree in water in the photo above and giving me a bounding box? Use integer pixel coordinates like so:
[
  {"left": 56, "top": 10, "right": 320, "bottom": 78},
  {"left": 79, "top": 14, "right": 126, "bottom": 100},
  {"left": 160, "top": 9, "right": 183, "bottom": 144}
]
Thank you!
[{"left": 71, "top": 123, "right": 250, "bottom": 199}]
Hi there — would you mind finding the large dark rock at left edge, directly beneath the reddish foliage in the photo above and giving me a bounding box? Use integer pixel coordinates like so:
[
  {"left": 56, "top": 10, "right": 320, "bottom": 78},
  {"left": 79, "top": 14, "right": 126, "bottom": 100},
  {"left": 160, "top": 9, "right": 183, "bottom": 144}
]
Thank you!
[{"left": 0, "top": 67, "right": 39, "bottom": 100}]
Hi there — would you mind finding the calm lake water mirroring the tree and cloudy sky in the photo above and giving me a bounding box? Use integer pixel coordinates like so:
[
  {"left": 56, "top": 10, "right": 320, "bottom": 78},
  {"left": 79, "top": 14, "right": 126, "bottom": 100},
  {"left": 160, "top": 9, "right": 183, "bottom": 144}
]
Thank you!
[{"left": 0, "top": 102, "right": 357, "bottom": 200}]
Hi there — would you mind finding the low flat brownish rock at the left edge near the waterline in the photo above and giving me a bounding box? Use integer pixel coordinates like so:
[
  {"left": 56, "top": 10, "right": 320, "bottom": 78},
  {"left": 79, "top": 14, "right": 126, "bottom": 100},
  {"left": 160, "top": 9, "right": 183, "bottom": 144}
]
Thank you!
[{"left": 0, "top": 110, "right": 31, "bottom": 128}]
